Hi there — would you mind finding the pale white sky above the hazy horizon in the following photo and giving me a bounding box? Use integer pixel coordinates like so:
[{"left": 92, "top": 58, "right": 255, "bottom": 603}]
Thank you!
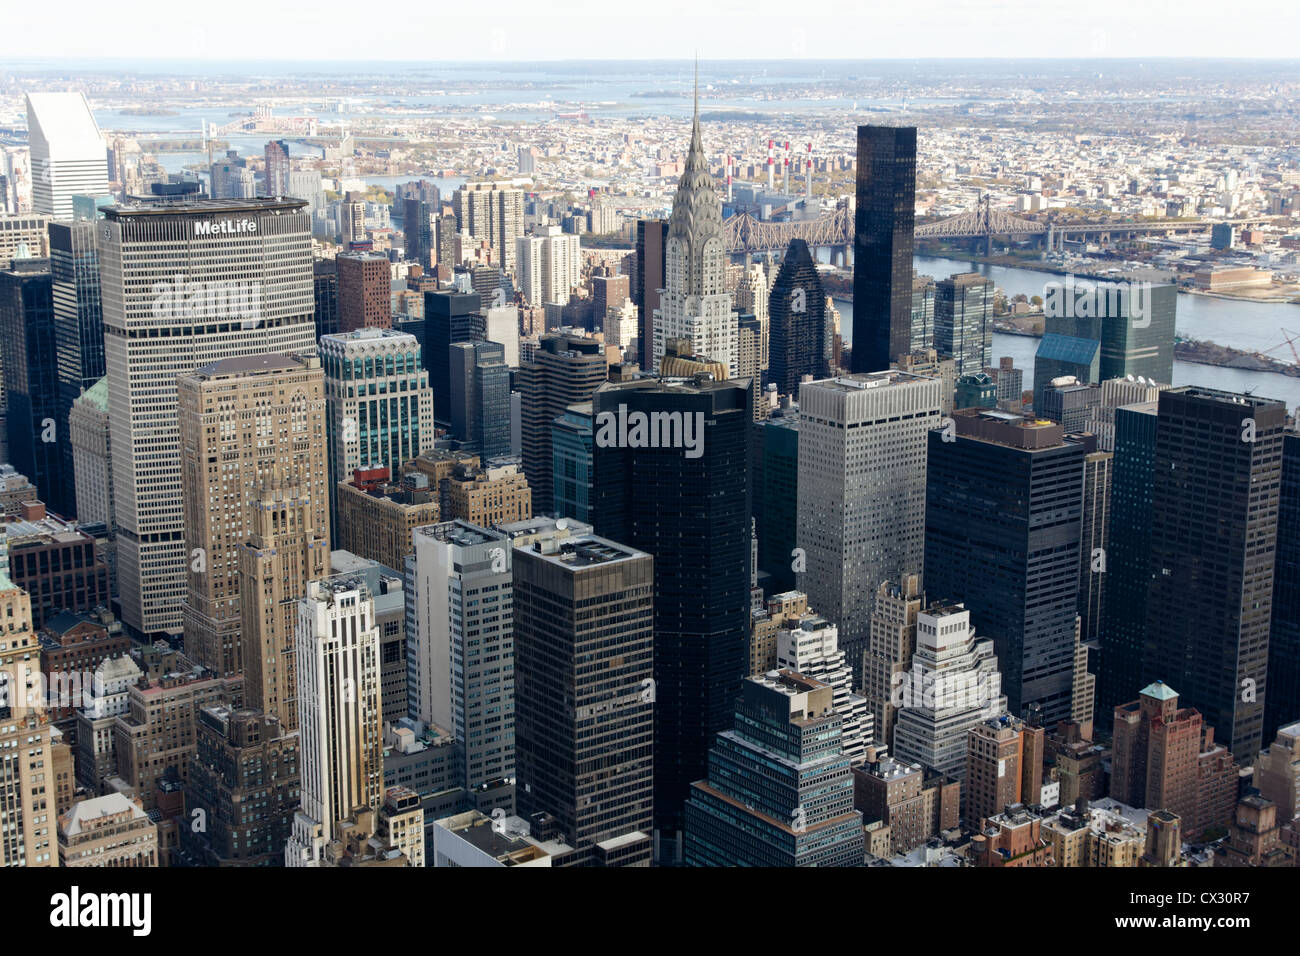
[{"left": 0, "top": 0, "right": 1300, "bottom": 61}]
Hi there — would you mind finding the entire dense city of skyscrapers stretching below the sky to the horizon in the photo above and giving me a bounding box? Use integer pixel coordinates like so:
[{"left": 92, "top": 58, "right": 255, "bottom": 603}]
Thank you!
[{"left": 0, "top": 60, "right": 1300, "bottom": 874}]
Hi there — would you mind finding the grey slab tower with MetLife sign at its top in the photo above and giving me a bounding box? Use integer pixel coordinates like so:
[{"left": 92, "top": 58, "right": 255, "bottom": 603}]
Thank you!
[{"left": 96, "top": 199, "right": 316, "bottom": 637}]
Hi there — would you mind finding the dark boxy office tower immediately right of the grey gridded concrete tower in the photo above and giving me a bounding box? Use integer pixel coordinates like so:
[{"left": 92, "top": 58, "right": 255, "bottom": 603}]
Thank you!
[{"left": 924, "top": 408, "right": 1086, "bottom": 727}]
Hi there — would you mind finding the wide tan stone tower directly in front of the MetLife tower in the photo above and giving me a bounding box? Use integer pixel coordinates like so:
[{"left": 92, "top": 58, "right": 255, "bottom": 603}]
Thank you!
[{"left": 177, "top": 355, "right": 329, "bottom": 681}]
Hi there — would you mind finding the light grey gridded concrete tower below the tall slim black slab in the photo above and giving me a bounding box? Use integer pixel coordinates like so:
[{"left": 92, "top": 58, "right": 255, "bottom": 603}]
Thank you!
[{"left": 796, "top": 371, "right": 940, "bottom": 687}]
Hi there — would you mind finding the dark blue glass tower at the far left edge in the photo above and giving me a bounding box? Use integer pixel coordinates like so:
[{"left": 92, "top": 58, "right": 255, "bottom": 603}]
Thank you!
[{"left": 0, "top": 259, "right": 73, "bottom": 515}]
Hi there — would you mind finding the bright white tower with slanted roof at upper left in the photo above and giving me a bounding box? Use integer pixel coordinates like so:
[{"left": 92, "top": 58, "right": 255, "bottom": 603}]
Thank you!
[{"left": 27, "top": 92, "right": 108, "bottom": 220}]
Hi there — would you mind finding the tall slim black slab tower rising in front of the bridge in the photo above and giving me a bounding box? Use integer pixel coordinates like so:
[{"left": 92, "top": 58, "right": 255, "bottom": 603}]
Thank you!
[{"left": 853, "top": 126, "right": 917, "bottom": 372}]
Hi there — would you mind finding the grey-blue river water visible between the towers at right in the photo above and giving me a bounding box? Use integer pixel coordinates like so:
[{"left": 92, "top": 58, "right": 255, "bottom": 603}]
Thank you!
[{"left": 835, "top": 256, "right": 1300, "bottom": 410}]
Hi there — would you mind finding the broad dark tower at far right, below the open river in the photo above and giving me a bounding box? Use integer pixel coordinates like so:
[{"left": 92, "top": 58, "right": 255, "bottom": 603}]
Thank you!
[{"left": 1143, "top": 386, "right": 1287, "bottom": 761}]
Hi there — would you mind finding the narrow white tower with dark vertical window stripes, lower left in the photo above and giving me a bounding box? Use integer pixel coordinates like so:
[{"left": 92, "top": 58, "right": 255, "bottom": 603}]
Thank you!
[{"left": 285, "top": 574, "right": 384, "bottom": 866}]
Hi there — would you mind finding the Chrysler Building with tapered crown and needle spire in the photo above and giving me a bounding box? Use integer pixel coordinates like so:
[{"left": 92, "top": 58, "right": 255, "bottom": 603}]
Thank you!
[{"left": 651, "top": 75, "right": 740, "bottom": 376}]
